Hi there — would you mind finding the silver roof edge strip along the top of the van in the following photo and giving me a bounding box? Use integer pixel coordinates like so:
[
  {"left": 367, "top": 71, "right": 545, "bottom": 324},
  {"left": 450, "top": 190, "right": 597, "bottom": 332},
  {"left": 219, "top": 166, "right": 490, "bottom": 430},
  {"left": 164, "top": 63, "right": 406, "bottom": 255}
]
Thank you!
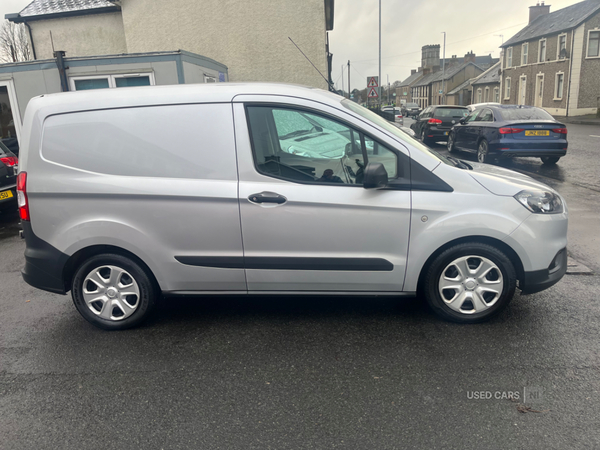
[{"left": 27, "top": 83, "right": 343, "bottom": 116}]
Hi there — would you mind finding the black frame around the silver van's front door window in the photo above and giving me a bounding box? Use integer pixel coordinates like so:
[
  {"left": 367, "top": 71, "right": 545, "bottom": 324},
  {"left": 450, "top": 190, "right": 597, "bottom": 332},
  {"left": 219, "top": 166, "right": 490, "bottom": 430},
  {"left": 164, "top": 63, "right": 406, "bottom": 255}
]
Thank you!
[{"left": 244, "top": 102, "right": 411, "bottom": 190}]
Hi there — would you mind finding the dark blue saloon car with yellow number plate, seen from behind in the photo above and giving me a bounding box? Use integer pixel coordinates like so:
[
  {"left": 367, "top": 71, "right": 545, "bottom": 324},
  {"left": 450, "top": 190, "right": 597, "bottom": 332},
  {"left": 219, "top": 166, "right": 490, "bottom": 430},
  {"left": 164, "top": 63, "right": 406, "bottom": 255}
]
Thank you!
[{"left": 448, "top": 105, "right": 568, "bottom": 164}]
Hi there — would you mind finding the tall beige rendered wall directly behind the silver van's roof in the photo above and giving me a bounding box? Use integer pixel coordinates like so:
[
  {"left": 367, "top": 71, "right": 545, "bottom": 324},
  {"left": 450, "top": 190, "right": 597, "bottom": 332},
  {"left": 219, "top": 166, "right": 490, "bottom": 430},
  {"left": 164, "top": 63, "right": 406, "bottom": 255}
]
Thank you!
[{"left": 121, "top": 0, "right": 327, "bottom": 88}]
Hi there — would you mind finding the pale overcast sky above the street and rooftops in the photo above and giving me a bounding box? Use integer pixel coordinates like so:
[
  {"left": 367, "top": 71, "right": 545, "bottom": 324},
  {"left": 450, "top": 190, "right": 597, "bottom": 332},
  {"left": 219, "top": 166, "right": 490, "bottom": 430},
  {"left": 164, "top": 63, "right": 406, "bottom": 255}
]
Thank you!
[{"left": 0, "top": 0, "right": 579, "bottom": 90}]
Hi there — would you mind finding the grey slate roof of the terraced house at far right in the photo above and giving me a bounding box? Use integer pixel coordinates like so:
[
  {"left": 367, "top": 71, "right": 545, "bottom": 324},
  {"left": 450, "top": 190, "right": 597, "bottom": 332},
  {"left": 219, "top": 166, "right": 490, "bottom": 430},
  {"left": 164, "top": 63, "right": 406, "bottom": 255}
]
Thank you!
[{"left": 501, "top": 0, "right": 600, "bottom": 48}]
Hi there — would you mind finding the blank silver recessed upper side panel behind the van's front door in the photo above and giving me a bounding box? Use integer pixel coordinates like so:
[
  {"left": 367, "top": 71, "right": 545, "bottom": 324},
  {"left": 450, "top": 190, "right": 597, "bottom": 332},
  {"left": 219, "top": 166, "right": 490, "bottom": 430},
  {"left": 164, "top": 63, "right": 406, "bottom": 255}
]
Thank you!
[{"left": 42, "top": 104, "right": 237, "bottom": 180}]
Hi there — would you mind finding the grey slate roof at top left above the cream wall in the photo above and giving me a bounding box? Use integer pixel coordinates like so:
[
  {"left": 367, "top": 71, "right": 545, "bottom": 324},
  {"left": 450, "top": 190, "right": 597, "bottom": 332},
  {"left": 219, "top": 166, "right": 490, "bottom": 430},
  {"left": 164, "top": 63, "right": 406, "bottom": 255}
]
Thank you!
[{"left": 6, "top": 0, "right": 120, "bottom": 22}]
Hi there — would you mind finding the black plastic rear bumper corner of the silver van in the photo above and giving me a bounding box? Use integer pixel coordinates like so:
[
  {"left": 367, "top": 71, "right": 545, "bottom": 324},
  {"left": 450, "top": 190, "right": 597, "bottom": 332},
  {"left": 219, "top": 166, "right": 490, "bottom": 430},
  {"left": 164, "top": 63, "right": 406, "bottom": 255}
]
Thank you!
[{"left": 21, "top": 221, "right": 69, "bottom": 294}]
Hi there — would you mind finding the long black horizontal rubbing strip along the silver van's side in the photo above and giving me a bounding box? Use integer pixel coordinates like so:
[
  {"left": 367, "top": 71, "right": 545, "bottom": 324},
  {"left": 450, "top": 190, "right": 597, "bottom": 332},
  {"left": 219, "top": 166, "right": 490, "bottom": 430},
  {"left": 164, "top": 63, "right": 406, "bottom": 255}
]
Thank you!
[{"left": 175, "top": 256, "right": 394, "bottom": 272}]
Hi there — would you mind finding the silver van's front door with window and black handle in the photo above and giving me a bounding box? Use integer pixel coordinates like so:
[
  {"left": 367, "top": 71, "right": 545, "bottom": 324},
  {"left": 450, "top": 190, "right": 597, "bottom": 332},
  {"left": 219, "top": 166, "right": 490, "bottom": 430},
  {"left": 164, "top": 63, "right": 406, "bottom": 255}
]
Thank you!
[{"left": 234, "top": 99, "right": 410, "bottom": 293}]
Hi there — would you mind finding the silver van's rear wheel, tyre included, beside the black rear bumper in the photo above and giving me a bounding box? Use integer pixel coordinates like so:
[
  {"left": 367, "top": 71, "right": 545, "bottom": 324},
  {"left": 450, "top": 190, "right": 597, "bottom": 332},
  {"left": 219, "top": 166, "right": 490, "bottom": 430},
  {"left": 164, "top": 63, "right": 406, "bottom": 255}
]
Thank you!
[{"left": 71, "top": 253, "right": 159, "bottom": 330}]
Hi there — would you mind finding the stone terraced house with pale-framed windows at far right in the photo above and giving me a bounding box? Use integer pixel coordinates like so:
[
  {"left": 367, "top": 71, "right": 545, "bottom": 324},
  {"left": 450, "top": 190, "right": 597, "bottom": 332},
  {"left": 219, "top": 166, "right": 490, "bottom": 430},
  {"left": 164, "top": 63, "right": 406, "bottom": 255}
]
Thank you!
[{"left": 500, "top": 0, "right": 600, "bottom": 116}]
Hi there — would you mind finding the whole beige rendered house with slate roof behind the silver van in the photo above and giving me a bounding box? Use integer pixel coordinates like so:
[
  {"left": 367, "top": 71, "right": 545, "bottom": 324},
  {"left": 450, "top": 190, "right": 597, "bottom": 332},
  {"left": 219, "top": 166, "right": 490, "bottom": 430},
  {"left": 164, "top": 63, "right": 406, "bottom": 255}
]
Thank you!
[{"left": 6, "top": 0, "right": 334, "bottom": 89}]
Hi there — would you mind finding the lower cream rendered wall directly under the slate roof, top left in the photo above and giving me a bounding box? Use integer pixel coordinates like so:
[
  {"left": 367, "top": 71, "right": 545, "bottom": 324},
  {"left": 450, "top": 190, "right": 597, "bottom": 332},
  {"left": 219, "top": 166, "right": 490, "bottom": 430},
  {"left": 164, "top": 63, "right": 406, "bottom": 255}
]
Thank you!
[{"left": 29, "top": 12, "right": 127, "bottom": 59}]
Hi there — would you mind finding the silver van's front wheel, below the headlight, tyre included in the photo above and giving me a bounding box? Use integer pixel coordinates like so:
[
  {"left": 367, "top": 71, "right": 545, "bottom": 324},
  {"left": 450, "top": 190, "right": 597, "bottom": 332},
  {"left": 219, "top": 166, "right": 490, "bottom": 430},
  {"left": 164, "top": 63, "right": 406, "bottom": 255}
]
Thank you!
[{"left": 422, "top": 242, "right": 517, "bottom": 323}]
